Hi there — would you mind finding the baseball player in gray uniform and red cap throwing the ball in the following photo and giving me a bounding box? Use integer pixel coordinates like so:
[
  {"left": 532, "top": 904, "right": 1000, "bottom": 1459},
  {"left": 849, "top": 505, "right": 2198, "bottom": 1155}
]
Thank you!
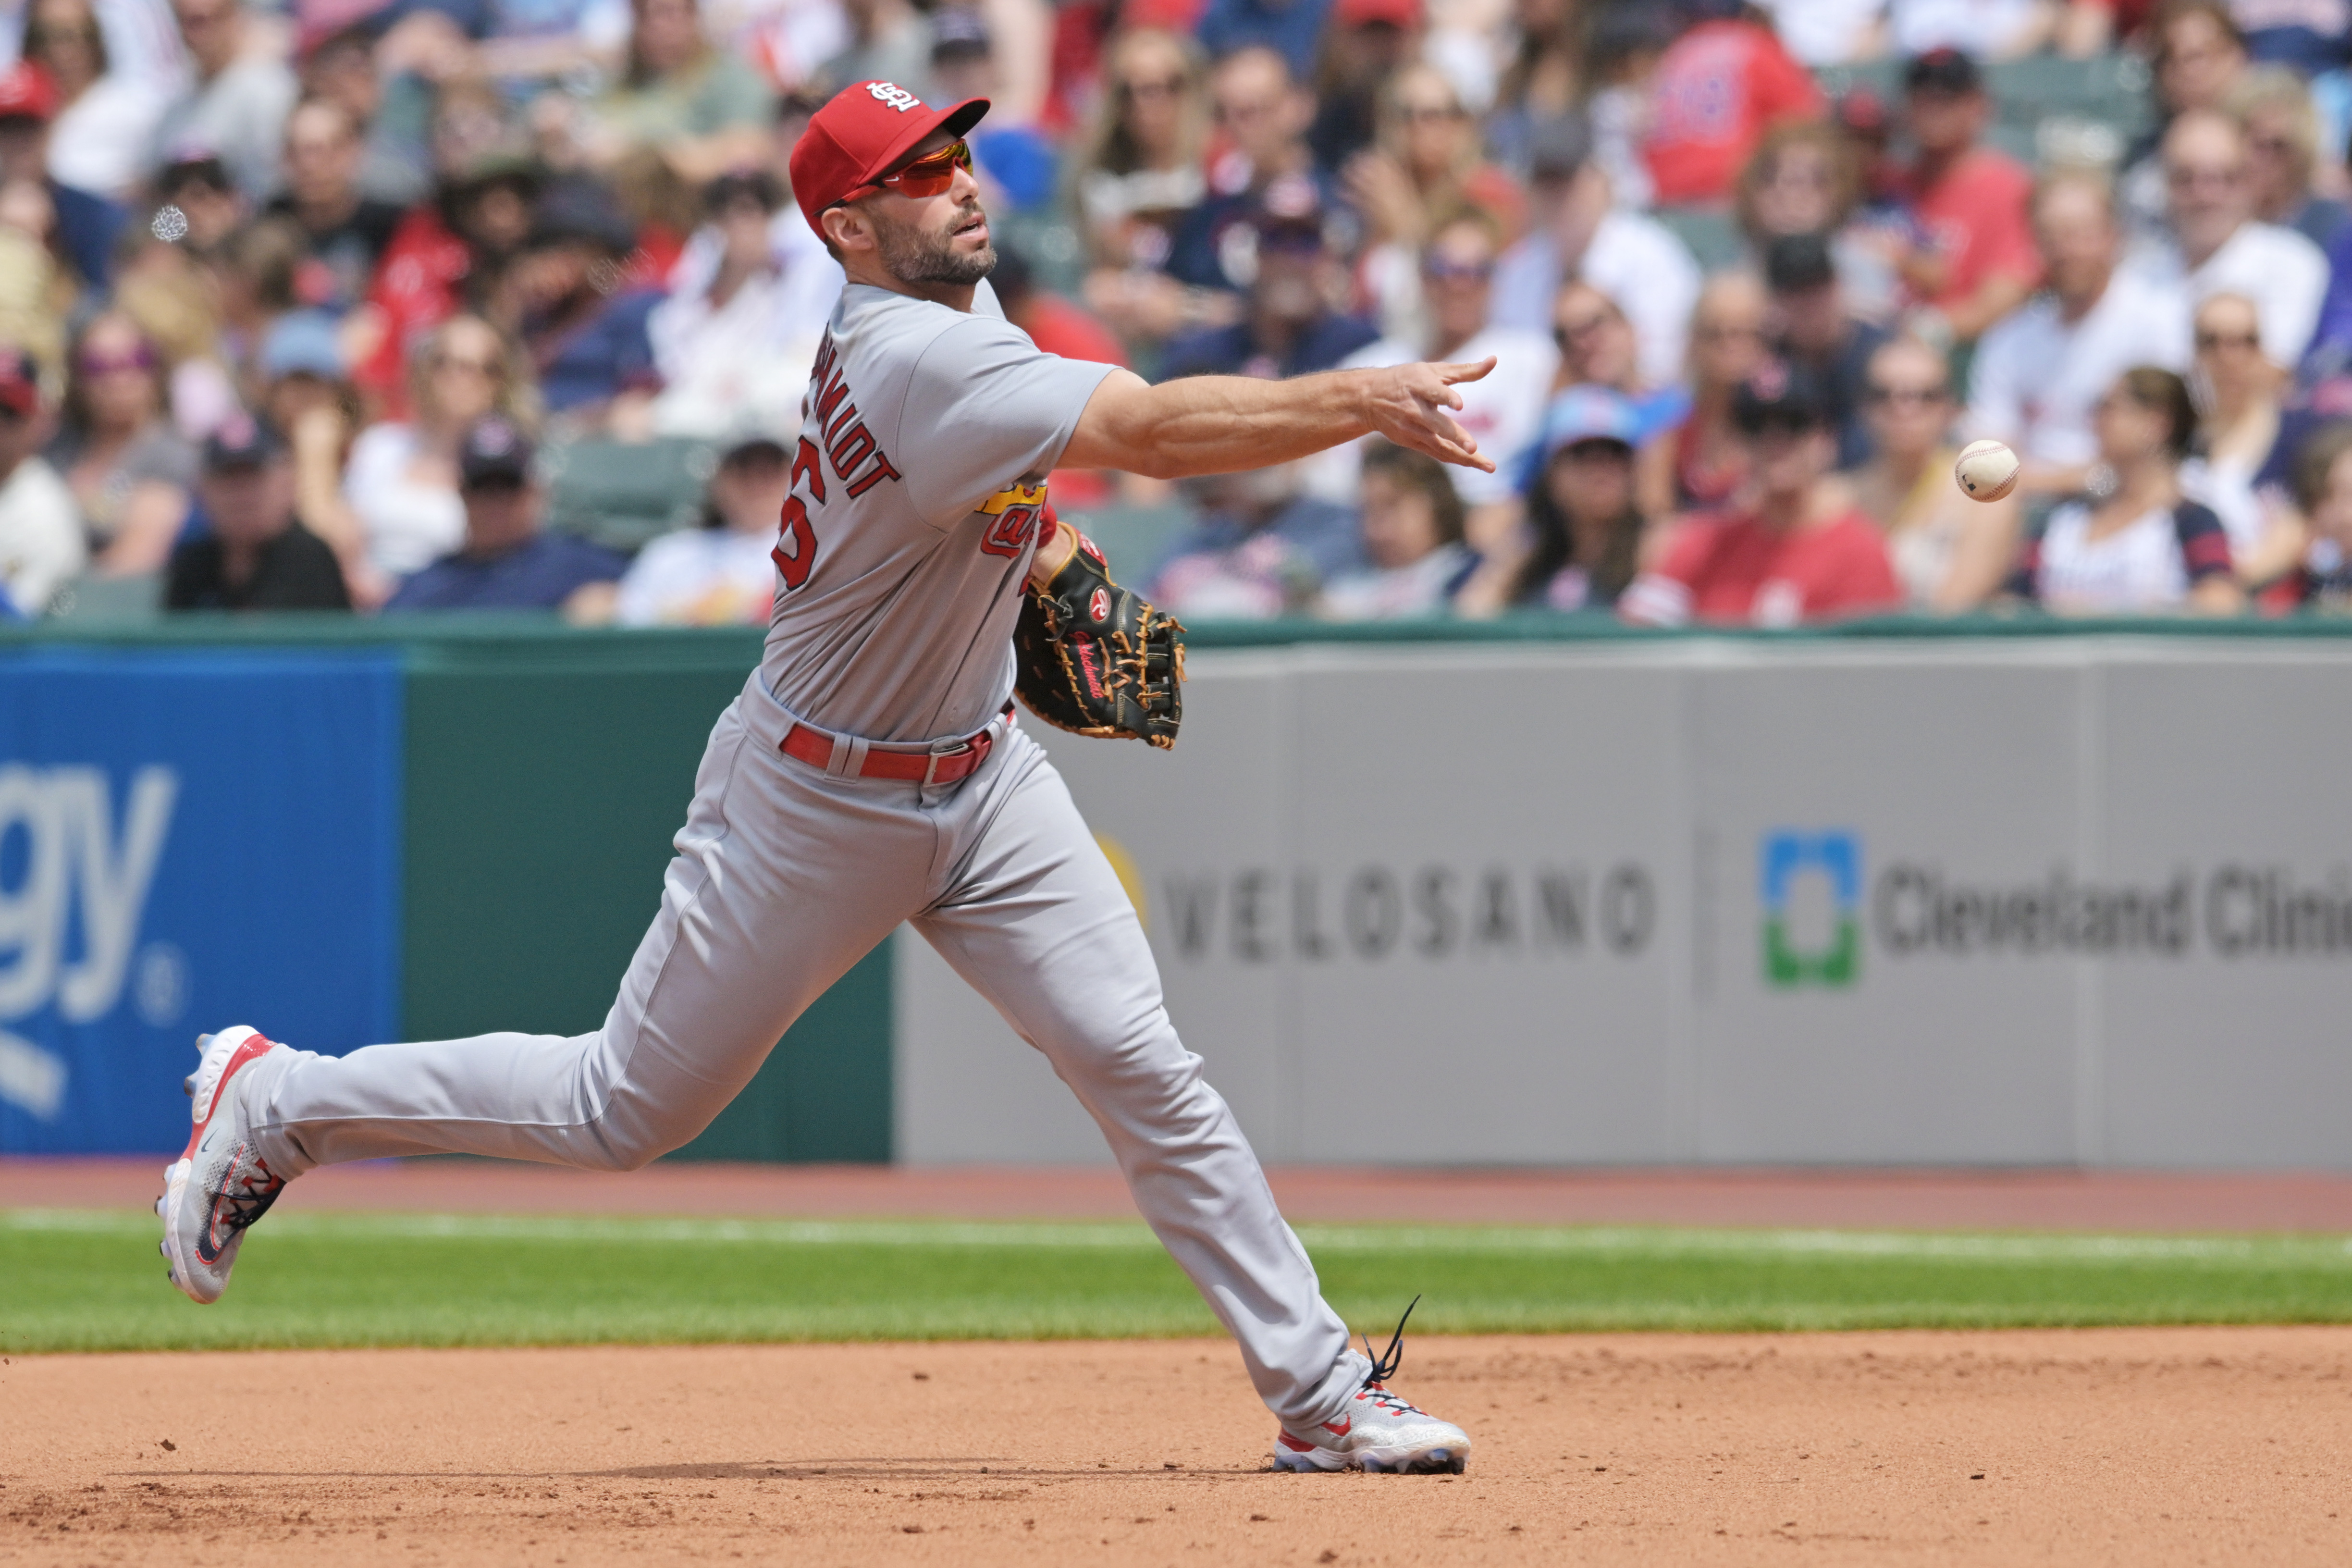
[{"left": 155, "top": 82, "right": 1493, "bottom": 1471}]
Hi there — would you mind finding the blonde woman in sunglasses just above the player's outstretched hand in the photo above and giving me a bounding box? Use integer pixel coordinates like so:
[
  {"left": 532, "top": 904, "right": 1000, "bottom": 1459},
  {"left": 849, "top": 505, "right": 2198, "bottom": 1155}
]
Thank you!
[{"left": 1343, "top": 63, "right": 1527, "bottom": 341}]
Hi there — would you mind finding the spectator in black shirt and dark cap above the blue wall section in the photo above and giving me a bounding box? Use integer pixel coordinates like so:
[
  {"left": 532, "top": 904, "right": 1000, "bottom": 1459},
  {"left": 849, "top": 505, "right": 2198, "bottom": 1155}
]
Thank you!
[{"left": 162, "top": 414, "right": 350, "bottom": 609}]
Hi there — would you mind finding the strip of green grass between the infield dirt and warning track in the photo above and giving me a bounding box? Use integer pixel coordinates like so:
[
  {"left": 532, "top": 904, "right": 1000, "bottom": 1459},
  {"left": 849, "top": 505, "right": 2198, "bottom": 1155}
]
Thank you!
[{"left": 0, "top": 1210, "right": 2352, "bottom": 1354}]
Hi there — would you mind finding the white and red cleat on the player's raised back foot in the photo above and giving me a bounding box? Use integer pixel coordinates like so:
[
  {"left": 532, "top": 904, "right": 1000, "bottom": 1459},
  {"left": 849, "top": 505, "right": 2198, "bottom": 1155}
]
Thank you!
[{"left": 155, "top": 1025, "right": 284, "bottom": 1305}]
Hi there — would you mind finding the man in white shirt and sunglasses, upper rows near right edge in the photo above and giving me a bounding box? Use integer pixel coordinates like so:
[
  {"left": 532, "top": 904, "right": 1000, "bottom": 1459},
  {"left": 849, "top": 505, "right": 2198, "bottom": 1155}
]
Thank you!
[{"left": 2133, "top": 111, "right": 2328, "bottom": 369}]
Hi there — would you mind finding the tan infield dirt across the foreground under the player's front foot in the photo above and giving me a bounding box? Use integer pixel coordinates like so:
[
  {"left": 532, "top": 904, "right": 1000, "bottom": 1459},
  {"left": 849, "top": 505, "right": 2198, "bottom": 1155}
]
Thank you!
[{"left": 0, "top": 1328, "right": 2352, "bottom": 1568}]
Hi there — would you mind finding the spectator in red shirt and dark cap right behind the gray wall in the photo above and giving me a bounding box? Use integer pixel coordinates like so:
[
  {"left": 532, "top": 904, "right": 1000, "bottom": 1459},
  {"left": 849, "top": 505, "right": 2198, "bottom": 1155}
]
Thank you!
[{"left": 1618, "top": 362, "right": 1903, "bottom": 625}]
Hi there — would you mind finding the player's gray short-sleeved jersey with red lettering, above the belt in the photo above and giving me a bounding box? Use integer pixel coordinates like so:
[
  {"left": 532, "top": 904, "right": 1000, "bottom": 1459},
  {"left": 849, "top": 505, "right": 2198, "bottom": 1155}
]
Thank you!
[{"left": 760, "top": 282, "right": 1110, "bottom": 741}]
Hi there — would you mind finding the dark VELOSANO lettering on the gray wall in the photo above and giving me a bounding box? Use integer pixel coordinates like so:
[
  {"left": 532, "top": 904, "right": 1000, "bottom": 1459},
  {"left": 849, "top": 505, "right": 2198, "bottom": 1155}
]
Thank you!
[{"left": 1162, "top": 863, "right": 1658, "bottom": 964}]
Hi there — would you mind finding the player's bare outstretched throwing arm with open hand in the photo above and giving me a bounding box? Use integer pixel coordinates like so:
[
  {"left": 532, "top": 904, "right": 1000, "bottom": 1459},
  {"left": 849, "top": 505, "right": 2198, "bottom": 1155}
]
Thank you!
[{"left": 1059, "top": 358, "right": 1493, "bottom": 480}]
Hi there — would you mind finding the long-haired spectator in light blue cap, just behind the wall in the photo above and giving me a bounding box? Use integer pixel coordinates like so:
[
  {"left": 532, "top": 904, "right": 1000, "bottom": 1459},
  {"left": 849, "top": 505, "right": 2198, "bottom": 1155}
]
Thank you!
[{"left": 1508, "top": 385, "right": 1649, "bottom": 611}]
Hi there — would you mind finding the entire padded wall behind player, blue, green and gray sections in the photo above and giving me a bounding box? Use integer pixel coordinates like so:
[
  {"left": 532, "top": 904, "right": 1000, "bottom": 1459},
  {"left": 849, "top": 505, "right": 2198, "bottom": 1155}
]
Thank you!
[{"left": 0, "top": 618, "right": 2352, "bottom": 1166}]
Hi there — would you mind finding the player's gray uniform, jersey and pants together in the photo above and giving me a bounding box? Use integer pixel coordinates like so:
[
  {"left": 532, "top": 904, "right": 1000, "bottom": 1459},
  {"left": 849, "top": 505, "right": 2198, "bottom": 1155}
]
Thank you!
[{"left": 222, "top": 270, "right": 1369, "bottom": 1432}]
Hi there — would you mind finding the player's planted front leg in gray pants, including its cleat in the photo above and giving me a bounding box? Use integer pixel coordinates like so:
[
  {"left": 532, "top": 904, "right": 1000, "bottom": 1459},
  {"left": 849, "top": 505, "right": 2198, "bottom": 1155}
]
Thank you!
[{"left": 915, "top": 731, "right": 1470, "bottom": 1469}]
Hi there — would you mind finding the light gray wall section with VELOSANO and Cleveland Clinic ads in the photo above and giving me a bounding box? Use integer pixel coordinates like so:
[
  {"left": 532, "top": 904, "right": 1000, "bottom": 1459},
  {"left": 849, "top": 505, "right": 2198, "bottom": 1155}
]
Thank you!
[{"left": 894, "top": 637, "right": 2352, "bottom": 1166}]
